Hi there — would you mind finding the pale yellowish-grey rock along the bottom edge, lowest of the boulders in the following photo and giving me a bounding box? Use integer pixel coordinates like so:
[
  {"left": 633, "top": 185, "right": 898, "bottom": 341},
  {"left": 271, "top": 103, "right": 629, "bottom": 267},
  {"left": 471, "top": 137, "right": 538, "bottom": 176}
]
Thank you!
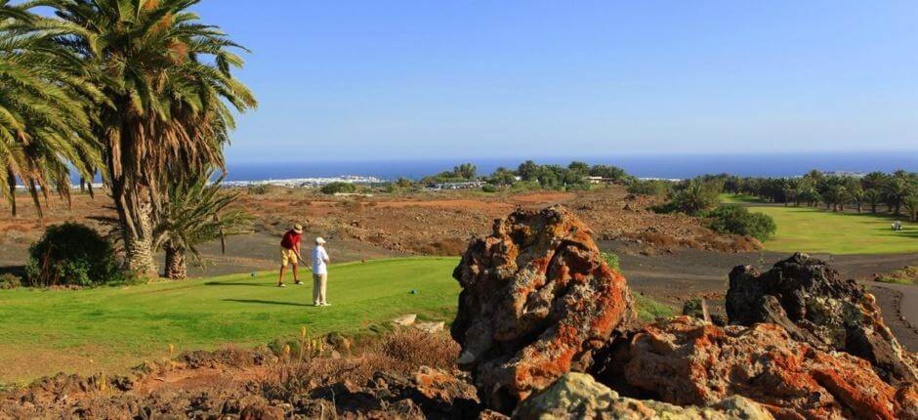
[{"left": 513, "top": 373, "right": 774, "bottom": 420}]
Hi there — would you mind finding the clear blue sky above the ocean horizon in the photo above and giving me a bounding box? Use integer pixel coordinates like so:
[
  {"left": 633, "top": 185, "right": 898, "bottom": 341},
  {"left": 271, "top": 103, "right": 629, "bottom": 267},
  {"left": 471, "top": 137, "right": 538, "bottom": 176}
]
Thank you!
[{"left": 197, "top": 0, "right": 918, "bottom": 163}]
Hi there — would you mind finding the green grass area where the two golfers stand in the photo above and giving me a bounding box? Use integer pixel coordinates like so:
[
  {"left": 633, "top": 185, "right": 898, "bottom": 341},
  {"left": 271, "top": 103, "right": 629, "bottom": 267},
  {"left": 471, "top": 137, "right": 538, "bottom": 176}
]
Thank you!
[{"left": 0, "top": 258, "right": 459, "bottom": 384}]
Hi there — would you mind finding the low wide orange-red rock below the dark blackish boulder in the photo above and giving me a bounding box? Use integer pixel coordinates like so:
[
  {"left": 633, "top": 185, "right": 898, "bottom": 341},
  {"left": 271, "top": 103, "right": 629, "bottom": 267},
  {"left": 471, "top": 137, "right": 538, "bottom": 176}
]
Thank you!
[{"left": 616, "top": 317, "right": 918, "bottom": 419}]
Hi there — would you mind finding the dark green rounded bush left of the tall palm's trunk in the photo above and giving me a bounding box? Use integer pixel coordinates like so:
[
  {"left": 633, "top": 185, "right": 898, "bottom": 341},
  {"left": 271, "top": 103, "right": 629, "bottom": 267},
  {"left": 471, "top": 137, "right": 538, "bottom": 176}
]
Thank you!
[{"left": 26, "top": 223, "right": 125, "bottom": 287}]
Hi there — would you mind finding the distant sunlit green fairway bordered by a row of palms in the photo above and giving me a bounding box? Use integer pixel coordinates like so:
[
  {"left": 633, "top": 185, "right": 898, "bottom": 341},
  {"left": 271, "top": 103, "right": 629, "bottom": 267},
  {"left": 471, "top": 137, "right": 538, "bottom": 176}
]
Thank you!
[{"left": 724, "top": 197, "right": 918, "bottom": 255}]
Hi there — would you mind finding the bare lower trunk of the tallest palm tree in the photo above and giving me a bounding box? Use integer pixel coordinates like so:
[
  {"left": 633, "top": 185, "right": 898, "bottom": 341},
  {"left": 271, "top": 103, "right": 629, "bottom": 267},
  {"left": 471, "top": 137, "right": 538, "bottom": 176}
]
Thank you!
[{"left": 112, "top": 176, "right": 157, "bottom": 277}]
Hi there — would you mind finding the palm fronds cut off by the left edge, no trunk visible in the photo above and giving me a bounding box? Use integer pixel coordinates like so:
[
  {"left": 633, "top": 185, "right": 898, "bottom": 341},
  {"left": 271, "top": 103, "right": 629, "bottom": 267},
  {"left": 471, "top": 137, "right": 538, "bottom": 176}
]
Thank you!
[{"left": 0, "top": 4, "right": 101, "bottom": 215}]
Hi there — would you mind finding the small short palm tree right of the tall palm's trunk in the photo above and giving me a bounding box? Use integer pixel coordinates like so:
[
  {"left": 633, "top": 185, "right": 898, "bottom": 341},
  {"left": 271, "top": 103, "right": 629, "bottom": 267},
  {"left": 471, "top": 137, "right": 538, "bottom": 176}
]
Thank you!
[{"left": 154, "top": 171, "right": 252, "bottom": 280}]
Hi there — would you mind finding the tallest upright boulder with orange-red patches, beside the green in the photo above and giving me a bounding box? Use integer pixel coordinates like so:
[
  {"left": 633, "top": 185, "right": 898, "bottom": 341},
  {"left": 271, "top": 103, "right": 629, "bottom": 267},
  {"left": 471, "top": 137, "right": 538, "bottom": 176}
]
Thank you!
[{"left": 451, "top": 207, "right": 635, "bottom": 413}]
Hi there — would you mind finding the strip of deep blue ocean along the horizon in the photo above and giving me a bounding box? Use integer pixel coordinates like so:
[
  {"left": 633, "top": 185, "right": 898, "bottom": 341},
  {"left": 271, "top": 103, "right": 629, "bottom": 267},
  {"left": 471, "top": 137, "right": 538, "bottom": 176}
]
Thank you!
[{"left": 227, "top": 151, "right": 918, "bottom": 181}]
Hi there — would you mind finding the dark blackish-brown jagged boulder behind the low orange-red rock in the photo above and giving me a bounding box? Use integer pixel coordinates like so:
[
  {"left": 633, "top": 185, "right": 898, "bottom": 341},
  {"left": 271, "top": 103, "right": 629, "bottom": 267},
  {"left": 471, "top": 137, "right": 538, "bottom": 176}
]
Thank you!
[{"left": 726, "top": 254, "right": 918, "bottom": 384}]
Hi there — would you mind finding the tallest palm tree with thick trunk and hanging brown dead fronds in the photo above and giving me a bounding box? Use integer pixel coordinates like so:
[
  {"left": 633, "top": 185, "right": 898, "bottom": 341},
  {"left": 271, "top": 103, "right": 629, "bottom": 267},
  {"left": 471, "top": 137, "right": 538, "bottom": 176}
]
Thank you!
[{"left": 43, "top": 0, "right": 256, "bottom": 275}]
